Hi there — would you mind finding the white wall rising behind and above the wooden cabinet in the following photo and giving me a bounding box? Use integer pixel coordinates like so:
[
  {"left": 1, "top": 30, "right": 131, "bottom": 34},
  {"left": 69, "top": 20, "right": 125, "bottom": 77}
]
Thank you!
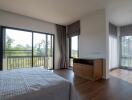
[{"left": 79, "top": 10, "right": 108, "bottom": 77}]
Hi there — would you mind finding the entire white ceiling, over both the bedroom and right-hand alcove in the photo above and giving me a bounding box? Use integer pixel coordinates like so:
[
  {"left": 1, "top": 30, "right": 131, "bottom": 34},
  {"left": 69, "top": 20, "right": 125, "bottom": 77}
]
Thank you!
[{"left": 0, "top": 0, "right": 132, "bottom": 26}]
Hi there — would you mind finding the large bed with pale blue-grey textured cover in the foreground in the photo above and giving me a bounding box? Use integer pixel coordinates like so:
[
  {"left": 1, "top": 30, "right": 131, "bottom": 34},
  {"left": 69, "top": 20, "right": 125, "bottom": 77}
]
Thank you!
[{"left": 0, "top": 68, "right": 78, "bottom": 100}]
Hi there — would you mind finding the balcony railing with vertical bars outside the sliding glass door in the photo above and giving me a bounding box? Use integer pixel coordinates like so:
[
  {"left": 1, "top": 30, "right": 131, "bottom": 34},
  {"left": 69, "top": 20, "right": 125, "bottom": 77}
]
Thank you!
[{"left": 6, "top": 56, "right": 52, "bottom": 70}]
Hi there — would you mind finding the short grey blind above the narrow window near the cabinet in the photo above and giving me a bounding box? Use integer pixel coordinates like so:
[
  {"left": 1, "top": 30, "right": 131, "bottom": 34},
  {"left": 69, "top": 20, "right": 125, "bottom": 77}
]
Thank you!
[{"left": 66, "top": 21, "right": 80, "bottom": 37}]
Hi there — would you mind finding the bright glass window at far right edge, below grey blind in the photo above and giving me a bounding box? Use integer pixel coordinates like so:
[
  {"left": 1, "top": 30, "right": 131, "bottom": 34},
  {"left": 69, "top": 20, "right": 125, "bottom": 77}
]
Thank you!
[{"left": 120, "top": 36, "right": 132, "bottom": 69}]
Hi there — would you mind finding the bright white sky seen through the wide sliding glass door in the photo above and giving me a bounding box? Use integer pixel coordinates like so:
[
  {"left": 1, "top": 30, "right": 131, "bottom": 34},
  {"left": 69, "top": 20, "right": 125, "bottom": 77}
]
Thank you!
[{"left": 6, "top": 29, "right": 50, "bottom": 47}]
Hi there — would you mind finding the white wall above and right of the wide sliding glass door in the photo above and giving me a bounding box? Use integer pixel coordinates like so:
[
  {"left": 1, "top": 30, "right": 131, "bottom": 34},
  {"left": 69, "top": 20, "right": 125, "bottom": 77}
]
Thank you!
[{"left": 0, "top": 10, "right": 60, "bottom": 68}]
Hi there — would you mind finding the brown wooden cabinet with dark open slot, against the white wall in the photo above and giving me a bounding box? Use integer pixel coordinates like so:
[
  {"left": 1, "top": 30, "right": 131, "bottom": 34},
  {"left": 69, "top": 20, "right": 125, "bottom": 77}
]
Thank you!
[{"left": 73, "top": 58, "right": 103, "bottom": 81}]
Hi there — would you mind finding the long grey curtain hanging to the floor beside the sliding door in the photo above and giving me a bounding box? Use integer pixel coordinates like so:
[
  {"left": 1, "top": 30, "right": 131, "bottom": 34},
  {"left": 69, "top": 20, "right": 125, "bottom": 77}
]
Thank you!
[{"left": 56, "top": 25, "right": 68, "bottom": 68}]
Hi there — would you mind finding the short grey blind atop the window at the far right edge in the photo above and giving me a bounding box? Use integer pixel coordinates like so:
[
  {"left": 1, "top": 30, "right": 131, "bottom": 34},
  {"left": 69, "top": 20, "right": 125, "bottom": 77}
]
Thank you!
[{"left": 120, "top": 25, "right": 132, "bottom": 36}]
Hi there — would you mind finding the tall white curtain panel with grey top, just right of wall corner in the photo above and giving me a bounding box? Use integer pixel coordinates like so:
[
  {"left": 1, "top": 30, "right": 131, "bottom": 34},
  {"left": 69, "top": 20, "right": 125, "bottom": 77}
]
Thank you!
[{"left": 109, "top": 24, "right": 119, "bottom": 69}]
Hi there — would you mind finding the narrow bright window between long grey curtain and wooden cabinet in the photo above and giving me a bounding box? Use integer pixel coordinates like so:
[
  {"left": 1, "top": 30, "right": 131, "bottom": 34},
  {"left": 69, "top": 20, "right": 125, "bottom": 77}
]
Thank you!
[{"left": 69, "top": 36, "right": 79, "bottom": 66}]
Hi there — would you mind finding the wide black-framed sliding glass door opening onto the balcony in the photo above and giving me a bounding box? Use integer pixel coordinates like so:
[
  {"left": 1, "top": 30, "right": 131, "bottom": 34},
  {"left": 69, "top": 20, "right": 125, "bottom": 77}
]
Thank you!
[{"left": 3, "top": 28, "right": 54, "bottom": 70}]
